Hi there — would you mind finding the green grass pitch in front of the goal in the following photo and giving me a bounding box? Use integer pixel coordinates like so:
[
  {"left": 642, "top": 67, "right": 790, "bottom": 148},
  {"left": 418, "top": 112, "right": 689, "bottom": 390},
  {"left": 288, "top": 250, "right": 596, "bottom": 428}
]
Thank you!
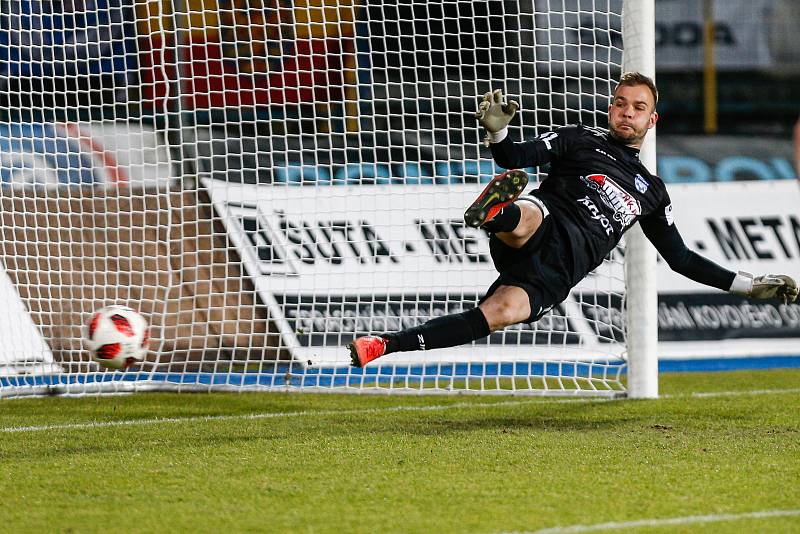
[{"left": 0, "top": 370, "right": 800, "bottom": 533}]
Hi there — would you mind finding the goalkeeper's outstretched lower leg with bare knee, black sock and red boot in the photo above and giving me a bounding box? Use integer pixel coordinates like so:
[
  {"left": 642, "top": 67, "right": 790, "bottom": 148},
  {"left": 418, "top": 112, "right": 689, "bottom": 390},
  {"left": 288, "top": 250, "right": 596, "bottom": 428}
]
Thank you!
[{"left": 348, "top": 286, "right": 531, "bottom": 367}]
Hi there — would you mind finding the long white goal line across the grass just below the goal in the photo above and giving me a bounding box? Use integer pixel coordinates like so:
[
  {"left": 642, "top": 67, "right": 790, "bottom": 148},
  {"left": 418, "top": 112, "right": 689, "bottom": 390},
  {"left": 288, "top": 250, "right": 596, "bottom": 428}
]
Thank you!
[{"left": 0, "top": 388, "right": 800, "bottom": 434}]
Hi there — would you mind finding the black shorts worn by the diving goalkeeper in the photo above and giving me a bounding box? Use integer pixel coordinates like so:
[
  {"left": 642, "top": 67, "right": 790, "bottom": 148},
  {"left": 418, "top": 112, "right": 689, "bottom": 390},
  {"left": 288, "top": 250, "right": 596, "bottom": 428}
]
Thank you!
[{"left": 480, "top": 197, "right": 585, "bottom": 323}]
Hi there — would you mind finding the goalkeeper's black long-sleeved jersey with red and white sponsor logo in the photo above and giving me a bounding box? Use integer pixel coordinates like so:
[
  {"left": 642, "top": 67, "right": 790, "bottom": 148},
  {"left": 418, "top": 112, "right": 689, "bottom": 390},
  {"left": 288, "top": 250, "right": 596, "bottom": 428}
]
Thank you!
[{"left": 491, "top": 124, "right": 735, "bottom": 290}]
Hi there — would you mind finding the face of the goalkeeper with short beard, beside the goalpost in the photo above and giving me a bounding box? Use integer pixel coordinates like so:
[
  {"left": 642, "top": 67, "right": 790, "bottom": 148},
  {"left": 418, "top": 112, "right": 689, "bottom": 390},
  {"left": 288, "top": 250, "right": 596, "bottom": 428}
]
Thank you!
[{"left": 608, "top": 85, "right": 658, "bottom": 148}]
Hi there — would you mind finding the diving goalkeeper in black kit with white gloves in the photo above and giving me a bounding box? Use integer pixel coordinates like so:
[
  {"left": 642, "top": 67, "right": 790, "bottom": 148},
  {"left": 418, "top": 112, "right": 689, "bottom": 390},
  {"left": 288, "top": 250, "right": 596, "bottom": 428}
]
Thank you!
[{"left": 348, "top": 72, "right": 798, "bottom": 367}]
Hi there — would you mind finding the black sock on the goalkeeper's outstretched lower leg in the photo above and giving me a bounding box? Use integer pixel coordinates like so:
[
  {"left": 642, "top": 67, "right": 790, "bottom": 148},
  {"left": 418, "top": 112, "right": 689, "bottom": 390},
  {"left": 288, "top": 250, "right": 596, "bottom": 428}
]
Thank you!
[{"left": 381, "top": 308, "right": 491, "bottom": 354}]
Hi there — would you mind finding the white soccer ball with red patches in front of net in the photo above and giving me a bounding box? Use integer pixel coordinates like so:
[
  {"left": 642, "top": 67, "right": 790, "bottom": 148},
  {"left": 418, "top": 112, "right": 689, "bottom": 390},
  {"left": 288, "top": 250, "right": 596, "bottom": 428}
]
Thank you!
[{"left": 86, "top": 305, "right": 150, "bottom": 369}]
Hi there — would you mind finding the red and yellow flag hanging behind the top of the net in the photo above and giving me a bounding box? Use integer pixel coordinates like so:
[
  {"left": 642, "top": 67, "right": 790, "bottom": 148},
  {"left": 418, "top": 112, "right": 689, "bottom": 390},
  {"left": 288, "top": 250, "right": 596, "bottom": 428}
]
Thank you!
[{"left": 138, "top": 0, "right": 358, "bottom": 110}]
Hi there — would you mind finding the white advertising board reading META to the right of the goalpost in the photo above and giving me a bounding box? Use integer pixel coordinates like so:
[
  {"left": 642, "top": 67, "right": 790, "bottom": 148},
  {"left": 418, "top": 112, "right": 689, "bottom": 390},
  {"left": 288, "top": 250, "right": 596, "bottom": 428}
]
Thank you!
[{"left": 658, "top": 180, "right": 800, "bottom": 358}]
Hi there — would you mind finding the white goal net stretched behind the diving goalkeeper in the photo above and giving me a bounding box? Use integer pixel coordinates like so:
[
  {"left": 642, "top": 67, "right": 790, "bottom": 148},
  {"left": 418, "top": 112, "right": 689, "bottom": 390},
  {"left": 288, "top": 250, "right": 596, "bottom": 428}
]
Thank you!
[{"left": 0, "top": 0, "right": 652, "bottom": 396}]
